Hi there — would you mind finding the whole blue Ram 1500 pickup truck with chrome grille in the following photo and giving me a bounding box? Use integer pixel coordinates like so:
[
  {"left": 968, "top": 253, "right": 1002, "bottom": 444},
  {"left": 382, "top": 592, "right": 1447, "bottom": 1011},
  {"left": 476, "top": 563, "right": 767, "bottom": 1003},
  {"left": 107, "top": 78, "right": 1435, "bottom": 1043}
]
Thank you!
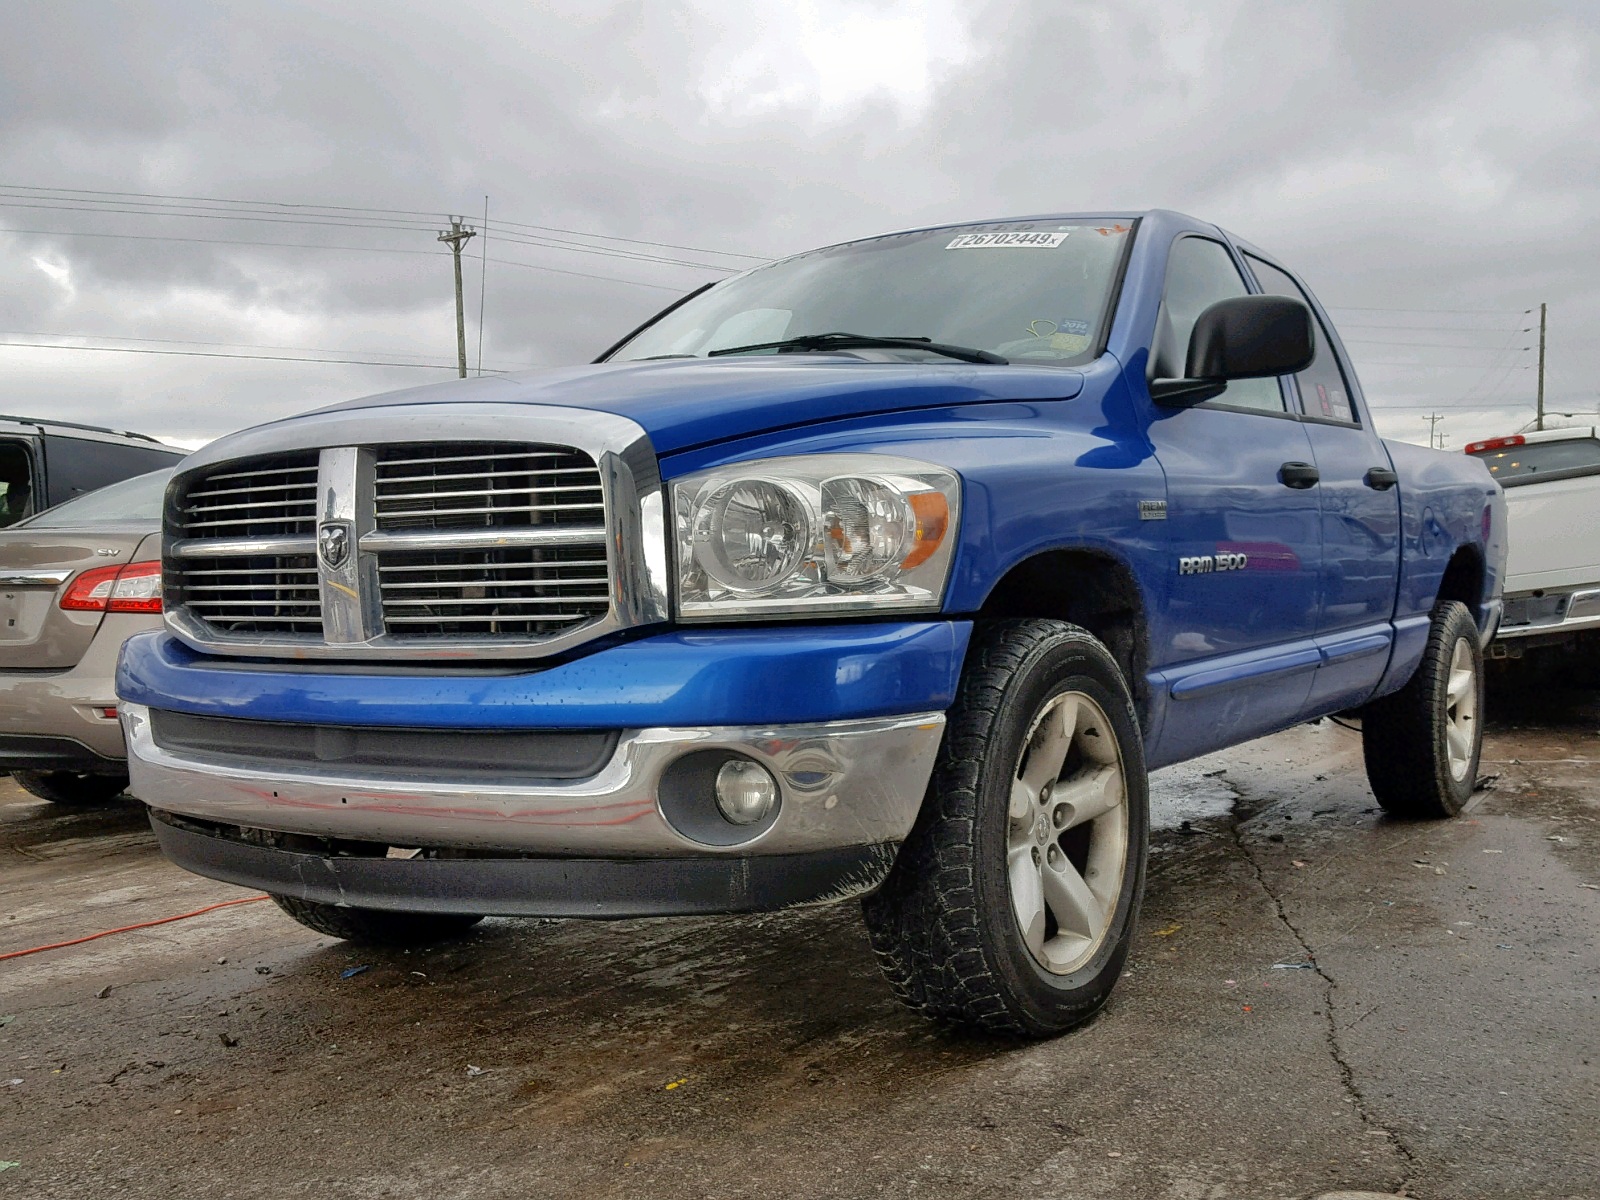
[{"left": 118, "top": 211, "right": 1506, "bottom": 1037}]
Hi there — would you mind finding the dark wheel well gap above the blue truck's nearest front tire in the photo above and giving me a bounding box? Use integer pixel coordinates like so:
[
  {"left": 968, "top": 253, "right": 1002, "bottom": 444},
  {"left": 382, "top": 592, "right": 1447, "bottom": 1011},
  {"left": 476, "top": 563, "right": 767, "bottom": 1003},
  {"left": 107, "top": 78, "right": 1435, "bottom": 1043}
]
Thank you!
[{"left": 978, "top": 550, "right": 1149, "bottom": 717}]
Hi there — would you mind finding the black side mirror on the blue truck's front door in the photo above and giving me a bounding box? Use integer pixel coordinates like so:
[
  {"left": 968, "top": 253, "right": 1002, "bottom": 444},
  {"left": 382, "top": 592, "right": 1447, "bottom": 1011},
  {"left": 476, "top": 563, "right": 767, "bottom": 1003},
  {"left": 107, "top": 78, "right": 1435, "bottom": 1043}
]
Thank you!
[{"left": 1150, "top": 296, "right": 1317, "bottom": 406}]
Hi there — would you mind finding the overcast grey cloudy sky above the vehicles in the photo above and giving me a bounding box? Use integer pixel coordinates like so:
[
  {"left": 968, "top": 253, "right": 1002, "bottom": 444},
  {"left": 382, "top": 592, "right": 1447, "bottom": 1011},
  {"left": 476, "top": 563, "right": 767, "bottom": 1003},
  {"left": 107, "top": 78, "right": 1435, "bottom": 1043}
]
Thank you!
[{"left": 0, "top": 0, "right": 1600, "bottom": 448}]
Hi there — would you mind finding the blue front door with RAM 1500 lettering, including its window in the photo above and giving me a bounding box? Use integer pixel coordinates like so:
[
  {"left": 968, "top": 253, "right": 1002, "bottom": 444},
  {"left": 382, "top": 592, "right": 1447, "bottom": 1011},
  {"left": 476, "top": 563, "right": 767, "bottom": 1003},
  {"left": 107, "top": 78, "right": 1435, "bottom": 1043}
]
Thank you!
[{"left": 1150, "top": 235, "right": 1322, "bottom": 762}]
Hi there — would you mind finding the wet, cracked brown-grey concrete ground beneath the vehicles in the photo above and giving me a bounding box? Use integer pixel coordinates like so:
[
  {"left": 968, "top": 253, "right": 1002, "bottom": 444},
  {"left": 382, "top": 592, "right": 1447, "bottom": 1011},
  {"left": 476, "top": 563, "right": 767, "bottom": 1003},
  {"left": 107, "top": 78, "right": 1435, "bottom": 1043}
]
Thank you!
[{"left": 0, "top": 693, "right": 1600, "bottom": 1200}]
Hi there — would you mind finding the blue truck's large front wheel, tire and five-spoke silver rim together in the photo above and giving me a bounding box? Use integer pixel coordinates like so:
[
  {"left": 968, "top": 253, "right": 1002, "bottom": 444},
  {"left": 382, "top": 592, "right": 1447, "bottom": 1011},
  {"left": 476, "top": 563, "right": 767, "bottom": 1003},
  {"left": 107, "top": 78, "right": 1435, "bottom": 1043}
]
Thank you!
[{"left": 864, "top": 621, "right": 1149, "bottom": 1037}]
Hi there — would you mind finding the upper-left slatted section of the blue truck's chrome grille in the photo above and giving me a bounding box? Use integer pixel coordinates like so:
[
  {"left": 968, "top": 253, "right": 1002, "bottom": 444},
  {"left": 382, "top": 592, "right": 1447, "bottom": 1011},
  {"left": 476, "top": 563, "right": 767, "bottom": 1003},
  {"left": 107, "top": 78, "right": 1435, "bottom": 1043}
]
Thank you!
[{"left": 178, "top": 451, "right": 317, "bottom": 538}]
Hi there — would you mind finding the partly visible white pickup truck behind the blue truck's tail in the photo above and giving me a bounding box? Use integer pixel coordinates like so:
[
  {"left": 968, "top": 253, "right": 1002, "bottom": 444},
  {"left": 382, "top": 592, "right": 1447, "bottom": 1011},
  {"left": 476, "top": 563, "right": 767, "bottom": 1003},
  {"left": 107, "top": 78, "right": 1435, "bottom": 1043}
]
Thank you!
[{"left": 1466, "top": 427, "right": 1600, "bottom": 658}]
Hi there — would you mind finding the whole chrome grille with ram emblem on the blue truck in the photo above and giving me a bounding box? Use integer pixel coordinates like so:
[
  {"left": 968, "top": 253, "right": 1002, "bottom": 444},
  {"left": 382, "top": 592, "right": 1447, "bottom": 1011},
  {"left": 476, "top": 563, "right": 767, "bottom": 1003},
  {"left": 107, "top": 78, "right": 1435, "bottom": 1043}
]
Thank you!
[{"left": 166, "top": 440, "right": 630, "bottom": 658}]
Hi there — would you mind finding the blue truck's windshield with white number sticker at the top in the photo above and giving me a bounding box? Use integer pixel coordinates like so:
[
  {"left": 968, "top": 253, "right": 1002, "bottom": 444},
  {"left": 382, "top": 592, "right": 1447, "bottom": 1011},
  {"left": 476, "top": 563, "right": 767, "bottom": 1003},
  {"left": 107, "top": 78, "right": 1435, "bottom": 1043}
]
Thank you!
[{"left": 608, "top": 218, "right": 1133, "bottom": 366}]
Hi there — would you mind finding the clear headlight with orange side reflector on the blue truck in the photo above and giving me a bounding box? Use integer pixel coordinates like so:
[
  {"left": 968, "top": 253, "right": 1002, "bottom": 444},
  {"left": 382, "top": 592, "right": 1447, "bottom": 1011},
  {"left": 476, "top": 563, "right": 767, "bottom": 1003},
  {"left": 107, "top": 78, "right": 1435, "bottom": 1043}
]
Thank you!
[{"left": 672, "top": 454, "right": 962, "bottom": 621}]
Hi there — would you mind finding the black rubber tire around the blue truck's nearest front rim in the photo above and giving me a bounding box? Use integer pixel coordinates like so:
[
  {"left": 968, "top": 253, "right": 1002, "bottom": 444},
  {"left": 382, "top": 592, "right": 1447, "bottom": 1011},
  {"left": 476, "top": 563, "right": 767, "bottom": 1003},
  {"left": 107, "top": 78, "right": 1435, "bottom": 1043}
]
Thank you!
[{"left": 862, "top": 621, "right": 1149, "bottom": 1038}]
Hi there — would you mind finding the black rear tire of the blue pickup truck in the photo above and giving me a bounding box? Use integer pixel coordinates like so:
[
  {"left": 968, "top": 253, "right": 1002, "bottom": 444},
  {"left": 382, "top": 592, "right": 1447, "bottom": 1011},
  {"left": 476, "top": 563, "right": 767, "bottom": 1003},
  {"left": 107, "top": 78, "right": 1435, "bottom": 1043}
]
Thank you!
[{"left": 1362, "top": 600, "right": 1483, "bottom": 821}]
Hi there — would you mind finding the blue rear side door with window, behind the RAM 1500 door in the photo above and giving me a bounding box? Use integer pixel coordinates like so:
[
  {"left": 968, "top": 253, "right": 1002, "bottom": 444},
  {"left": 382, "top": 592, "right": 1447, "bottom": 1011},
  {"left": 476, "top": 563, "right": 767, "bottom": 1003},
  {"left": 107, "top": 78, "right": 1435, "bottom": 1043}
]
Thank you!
[{"left": 1245, "top": 251, "right": 1400, "bottom": 712}]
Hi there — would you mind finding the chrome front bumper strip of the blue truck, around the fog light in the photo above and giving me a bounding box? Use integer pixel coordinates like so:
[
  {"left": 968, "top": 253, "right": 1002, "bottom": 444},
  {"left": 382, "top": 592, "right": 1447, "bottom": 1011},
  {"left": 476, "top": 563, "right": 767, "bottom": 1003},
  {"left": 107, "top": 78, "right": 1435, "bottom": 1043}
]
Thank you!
[{"left": 122, "top": 704, "right": 944, "bottom": 858}]
